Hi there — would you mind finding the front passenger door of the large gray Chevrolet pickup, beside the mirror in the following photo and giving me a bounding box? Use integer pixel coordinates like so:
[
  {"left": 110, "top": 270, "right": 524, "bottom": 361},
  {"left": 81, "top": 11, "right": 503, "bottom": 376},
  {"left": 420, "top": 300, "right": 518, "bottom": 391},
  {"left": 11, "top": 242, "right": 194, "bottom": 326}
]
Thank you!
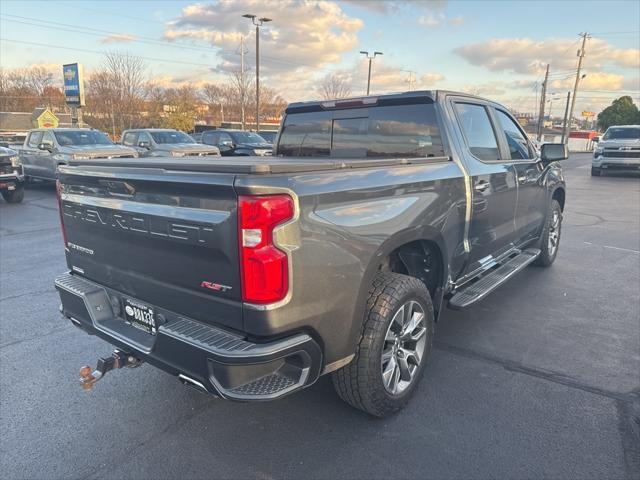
[{"left": 494, "top": 108, "right": 548, "bottom": 243}]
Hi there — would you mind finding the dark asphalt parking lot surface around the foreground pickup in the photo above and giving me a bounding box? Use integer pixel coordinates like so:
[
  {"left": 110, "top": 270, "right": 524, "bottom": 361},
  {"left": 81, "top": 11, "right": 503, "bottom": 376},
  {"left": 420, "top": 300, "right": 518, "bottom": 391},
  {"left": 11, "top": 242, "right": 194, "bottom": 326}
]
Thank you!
[{"left": 0, "top": 155, "right": 640, "bottom": 479}]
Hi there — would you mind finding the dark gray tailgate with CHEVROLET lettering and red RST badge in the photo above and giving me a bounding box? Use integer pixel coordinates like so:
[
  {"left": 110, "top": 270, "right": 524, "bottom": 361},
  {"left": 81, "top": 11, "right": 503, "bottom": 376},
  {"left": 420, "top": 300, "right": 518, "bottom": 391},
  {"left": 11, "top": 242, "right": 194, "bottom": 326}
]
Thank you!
[{"left": 59, "top": 165, "right": 242, "bottom": 329}]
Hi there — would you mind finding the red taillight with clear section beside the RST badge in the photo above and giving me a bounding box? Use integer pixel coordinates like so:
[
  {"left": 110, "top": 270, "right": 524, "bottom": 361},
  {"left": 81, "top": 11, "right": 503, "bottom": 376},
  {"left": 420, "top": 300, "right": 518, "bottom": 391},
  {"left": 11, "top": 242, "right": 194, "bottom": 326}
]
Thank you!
[{"left": 238, "top": 195, "right": 294, "bottom": 304}]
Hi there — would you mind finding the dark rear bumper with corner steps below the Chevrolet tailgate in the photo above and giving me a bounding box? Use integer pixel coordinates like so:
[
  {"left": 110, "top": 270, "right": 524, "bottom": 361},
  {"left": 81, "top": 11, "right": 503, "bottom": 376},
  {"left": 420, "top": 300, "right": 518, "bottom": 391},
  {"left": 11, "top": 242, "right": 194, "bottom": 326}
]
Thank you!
[{"left": 55, "top": 273, "right": 322, "bottom": 401}]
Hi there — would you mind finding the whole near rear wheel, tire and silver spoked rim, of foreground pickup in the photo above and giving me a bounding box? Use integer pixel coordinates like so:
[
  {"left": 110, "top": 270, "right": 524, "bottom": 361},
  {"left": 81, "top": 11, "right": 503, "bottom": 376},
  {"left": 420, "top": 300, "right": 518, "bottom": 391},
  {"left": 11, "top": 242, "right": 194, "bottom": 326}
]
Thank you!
[{"left": 332, "top": 273, "right": 434, "bottom": 417}]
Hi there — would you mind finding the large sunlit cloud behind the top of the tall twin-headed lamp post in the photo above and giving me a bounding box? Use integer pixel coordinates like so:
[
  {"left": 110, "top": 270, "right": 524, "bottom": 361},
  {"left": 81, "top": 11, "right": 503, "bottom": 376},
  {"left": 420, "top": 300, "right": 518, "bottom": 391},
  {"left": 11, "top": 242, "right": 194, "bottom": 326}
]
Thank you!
[{"left": 165, "top": 0, "right": 364, "bottom": 74}]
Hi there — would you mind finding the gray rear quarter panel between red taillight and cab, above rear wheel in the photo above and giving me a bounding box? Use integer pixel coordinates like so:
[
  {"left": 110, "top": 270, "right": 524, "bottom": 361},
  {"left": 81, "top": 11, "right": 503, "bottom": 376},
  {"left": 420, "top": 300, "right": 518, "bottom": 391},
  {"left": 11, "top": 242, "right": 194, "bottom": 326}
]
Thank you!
[{"left": 235, "top": 161, "right": 465, "bottom": 364}]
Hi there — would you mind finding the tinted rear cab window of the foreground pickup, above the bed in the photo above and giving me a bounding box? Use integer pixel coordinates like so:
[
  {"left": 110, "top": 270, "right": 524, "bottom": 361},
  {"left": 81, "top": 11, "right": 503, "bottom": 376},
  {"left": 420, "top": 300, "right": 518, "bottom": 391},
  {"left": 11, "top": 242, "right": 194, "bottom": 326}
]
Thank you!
[{"left": 277, "top": 103, "right": 446, "bottom": 158}]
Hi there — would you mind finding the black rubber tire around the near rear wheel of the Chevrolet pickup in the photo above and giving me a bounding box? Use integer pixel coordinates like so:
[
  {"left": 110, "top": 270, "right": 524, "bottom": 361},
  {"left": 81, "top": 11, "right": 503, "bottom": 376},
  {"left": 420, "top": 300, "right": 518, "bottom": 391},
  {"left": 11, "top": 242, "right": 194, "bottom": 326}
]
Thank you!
[{"left": 332, "top": 273, "right": 434, "bottom": 417}]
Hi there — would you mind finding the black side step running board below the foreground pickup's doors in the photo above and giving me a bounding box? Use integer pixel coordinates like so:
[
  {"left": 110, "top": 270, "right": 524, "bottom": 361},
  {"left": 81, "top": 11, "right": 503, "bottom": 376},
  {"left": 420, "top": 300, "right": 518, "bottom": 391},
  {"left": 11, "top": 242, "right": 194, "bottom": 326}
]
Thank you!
[{"left": 449, "top": 248, "right": 540, "bottom": 310}]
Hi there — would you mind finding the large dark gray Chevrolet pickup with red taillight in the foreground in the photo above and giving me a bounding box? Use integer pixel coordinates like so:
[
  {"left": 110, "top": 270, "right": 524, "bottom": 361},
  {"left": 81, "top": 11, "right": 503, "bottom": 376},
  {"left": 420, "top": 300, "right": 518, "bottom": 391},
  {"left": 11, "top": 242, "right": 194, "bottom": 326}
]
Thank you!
[{"left": 55, "top": 91, "right": 567, "bottom": 416}]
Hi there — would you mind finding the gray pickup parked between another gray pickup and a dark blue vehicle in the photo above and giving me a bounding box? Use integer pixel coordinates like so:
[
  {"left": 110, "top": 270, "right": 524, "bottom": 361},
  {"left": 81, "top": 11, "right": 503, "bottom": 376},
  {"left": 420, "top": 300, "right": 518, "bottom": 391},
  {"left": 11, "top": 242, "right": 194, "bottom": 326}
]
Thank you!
[{"left": 122, "top": 128, "right": 220, "bottom": 157}]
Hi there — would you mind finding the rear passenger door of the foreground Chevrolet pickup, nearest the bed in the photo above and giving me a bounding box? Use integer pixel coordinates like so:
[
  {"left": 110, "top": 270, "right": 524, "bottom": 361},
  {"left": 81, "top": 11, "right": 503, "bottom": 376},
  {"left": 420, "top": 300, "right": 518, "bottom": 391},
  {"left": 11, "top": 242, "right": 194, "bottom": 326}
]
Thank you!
[{"left": 450, "top": 97, "right": 517, "bottom": 272}]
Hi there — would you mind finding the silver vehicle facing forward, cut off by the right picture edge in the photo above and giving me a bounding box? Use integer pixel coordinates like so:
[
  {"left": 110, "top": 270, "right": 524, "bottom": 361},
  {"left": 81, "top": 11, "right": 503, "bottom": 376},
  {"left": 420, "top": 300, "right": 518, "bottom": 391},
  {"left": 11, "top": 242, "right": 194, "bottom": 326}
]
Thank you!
[{"left": 591, "top": 125, "right": 640, "bottom": 177}]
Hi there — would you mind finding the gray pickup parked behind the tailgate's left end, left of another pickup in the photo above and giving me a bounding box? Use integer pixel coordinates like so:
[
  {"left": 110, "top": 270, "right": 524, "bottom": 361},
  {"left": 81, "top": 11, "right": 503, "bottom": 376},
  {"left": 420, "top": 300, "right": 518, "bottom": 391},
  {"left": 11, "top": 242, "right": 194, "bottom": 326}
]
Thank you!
[{"left": 19, "top": 128, "right": 138, "bottom": 180}]
